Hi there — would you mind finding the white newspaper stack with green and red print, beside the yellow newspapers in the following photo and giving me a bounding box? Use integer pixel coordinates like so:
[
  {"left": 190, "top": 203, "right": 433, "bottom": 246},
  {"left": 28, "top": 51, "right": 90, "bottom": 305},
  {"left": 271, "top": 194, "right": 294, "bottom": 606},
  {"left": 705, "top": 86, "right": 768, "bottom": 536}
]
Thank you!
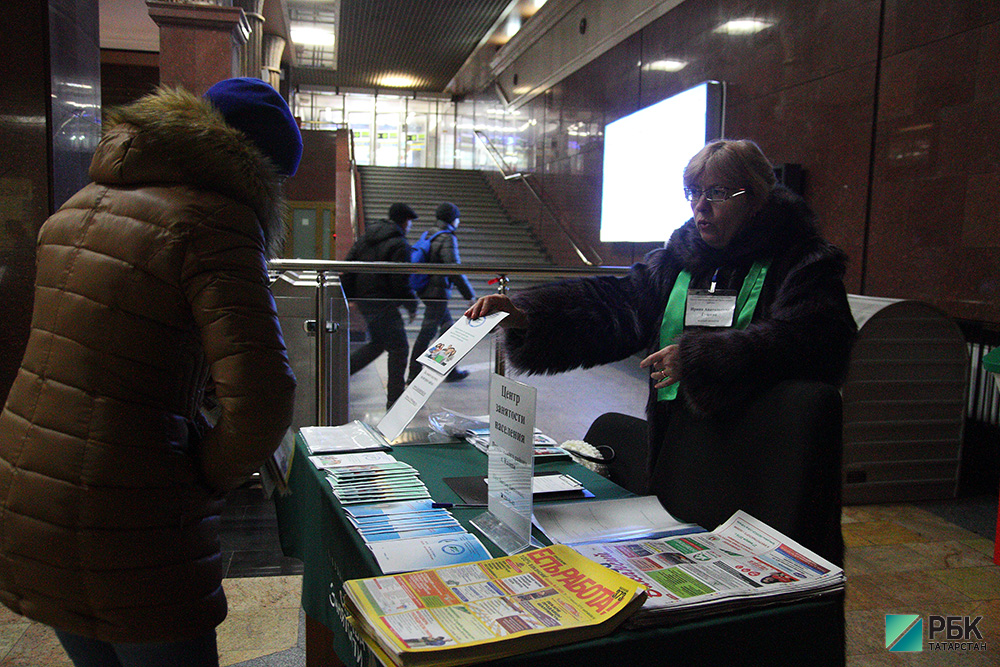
[{"left": 574, "top": 511, "right": 844, "bottom": 627}]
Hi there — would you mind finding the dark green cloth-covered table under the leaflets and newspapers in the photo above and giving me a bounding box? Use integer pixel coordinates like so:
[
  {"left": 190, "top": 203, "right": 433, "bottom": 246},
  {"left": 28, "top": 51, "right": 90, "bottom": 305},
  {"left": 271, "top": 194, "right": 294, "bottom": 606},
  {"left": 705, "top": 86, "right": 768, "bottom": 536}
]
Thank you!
[{"left": 276, "top": 439, "right": 844, "bottom": 667}]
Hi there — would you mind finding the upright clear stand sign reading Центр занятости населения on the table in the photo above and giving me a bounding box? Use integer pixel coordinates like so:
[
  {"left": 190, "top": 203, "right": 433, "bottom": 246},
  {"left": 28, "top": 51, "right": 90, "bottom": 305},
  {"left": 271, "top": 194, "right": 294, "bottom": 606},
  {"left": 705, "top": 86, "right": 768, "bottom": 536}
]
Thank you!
[{"left": 472, "top": 373, "right": 540, "bottom": 554}]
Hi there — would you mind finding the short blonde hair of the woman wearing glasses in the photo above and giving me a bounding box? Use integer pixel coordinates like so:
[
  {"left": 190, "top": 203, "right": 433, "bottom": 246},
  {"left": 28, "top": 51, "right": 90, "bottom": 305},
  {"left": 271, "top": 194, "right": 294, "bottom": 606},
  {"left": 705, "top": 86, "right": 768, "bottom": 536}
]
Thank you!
[{"left": 684, "top": 139, "right": 778, "bottom": 203}]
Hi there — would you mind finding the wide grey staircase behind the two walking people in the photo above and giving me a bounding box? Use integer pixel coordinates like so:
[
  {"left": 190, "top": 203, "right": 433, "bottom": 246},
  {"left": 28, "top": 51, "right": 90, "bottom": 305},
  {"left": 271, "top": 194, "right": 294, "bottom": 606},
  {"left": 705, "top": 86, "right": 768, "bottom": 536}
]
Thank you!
[{"left": 358, "top": 166, "right": 553, "bottom": 298}]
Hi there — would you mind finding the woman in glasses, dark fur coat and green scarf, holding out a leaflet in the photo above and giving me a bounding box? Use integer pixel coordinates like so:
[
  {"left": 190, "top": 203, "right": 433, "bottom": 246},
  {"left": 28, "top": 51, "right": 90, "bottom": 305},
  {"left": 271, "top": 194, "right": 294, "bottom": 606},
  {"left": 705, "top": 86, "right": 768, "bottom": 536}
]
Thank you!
[{"left": 465, "top": 140, "right": 856, "bottom": 528}]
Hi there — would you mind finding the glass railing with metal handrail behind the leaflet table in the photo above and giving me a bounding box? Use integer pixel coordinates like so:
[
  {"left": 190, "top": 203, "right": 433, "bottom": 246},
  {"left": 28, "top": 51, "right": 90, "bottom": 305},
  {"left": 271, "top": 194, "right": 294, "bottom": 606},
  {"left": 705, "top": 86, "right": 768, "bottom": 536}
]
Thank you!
[{"left": 270, "top": 260, "right": 648, "bottom": 443}]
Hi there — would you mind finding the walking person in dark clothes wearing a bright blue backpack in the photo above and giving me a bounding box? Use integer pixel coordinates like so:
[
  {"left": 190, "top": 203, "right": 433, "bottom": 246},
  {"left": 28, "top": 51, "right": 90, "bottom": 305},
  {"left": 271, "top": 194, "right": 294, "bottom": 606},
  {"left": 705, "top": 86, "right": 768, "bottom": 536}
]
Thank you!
[{"left": 409, "top": 202, "right": 476, "bottom": 382}]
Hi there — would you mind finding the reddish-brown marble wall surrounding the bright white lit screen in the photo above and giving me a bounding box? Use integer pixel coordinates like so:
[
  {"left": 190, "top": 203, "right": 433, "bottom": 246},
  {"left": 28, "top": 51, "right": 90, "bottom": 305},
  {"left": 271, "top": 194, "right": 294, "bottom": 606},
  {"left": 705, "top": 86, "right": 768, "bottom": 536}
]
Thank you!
[{"left": 482, "top": 0, "right": 1000, "bottom": 324}]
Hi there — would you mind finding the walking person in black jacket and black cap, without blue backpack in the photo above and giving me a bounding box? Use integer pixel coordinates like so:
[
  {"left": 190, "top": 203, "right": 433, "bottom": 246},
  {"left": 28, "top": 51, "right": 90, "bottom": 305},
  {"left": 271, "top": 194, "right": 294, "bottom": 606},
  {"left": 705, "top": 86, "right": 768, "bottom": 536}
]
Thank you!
[{"left": 344, "top": 204, "right": 417, "bottom": 407}]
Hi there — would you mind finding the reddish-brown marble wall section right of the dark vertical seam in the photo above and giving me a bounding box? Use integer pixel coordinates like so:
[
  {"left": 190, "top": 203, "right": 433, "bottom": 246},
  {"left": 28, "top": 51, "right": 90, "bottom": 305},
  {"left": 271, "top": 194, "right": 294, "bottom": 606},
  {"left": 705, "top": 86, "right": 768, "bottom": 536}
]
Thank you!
[{"left": 866, "top": 0, "right": 1000, "bottom": 323}]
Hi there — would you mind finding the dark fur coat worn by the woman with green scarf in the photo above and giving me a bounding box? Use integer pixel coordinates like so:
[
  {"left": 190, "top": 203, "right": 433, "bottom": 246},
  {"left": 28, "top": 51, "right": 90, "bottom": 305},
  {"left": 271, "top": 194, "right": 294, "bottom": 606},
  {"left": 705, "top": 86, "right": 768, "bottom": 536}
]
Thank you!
[{"left": 505, "top": 186, "right": 856, "bottom": 422}]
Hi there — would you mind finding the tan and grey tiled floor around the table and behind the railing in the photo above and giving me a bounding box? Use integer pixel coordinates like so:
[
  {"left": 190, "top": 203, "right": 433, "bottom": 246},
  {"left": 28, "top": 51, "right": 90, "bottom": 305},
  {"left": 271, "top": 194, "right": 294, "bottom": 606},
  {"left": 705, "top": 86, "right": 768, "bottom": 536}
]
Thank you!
[{"left": 0, "top": 335, "right": 1000, "bottom": 667}]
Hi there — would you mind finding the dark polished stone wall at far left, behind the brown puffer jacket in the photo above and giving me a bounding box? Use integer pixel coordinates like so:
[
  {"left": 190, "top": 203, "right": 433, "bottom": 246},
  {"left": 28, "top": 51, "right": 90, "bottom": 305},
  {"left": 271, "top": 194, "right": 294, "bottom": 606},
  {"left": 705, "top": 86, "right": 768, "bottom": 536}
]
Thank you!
[{"left": 0, "top": 0, "right": 101, "bottom": 402}]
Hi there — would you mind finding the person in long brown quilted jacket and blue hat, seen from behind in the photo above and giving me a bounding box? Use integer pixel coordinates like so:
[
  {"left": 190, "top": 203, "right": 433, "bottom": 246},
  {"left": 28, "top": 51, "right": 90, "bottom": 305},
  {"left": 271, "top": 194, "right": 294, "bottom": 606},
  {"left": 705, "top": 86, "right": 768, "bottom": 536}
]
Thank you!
[{"left": 0, "top": 79, "right": 302, "bottom": 665}]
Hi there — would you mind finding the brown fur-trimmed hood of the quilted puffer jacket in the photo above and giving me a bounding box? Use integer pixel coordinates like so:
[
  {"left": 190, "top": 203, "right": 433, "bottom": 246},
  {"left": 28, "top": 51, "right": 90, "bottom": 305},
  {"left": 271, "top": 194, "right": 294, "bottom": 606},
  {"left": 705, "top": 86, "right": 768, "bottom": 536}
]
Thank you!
[{"left": 90, "top": 88, "right": 285, "bottom": 257}]
